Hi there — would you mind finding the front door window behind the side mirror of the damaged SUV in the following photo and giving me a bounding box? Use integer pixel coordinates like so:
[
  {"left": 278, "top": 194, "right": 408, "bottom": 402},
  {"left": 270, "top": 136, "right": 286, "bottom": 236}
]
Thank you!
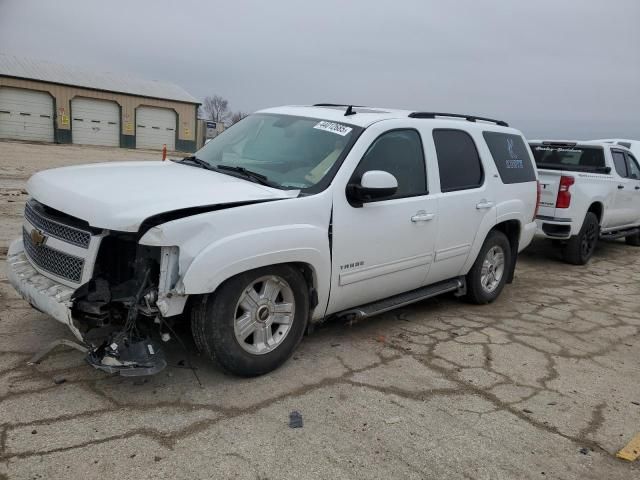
[{"left": 353, "top": 130, "right": 427, "bottom": 198}]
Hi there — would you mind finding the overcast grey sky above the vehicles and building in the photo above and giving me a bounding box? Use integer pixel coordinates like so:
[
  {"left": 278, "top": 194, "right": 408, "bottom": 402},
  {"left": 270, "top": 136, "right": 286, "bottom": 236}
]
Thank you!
[{"left": 0, "top": 0, "right": 640, "bottom": 139}]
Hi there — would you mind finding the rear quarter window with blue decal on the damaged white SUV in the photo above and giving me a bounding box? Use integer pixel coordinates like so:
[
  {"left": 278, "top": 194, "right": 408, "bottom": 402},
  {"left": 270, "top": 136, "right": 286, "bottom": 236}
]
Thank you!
[{"left": 482, "top": 132, "right": 536, "bottom": 183}]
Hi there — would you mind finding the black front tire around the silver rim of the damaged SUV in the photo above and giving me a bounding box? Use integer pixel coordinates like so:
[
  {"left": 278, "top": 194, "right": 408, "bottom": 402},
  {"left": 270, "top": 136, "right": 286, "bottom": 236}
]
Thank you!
[{"left": 191, "top": 265, "right": 309, "bottom": 377}]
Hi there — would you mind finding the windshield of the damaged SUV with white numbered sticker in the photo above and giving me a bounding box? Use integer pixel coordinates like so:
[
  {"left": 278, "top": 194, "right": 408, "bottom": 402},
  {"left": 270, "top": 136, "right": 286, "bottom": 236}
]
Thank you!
[{"left": 196, "top": 114, "right": 361, "bottom": 189}]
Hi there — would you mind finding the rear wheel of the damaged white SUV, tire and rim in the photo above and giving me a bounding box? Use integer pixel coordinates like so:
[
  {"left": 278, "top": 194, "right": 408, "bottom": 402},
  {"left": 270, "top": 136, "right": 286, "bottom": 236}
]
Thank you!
[{"left": 466, "top": 230, "right": 511, "bottom": 305}]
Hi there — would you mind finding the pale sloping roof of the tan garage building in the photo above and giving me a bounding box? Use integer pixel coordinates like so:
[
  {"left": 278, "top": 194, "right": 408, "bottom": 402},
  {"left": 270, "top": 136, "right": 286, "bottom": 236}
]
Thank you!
[{"left": 0, "top": 53, "right": 200, "bottom": 103}]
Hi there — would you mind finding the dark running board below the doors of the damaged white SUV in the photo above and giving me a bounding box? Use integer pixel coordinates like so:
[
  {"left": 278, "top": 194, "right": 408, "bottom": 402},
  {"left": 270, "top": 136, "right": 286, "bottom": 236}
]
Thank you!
[{"left": 337, "top": 277, "right": 467, "bottom": 319}]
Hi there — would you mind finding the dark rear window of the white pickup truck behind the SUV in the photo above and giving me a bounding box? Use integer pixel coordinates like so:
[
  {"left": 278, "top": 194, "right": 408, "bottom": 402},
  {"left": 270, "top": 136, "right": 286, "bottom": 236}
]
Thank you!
[{"left": 531, "top": 145, "right": 605, "bottom": 171}]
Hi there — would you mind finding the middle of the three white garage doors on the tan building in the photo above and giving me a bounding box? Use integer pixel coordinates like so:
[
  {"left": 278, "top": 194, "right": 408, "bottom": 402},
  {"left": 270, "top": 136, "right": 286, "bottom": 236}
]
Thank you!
[{"left": 71, "top": 98, "right": 120, "bottom": 147}]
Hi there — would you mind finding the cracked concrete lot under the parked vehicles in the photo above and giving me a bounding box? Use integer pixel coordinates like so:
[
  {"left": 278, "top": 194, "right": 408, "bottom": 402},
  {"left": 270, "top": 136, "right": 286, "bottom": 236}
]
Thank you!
[{"left": 0, "top": 142, "right": 640, "bottom": 480}]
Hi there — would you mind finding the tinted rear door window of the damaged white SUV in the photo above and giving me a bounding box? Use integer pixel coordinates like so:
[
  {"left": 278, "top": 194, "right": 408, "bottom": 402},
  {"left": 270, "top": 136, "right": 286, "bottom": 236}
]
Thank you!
[{"left": 433, "top": 130, "right": 483, "bottom": 192}]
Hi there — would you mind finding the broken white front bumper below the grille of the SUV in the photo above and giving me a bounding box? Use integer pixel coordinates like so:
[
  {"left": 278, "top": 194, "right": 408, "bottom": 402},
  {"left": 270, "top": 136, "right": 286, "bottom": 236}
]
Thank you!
[{"left": 7, "top": 239, "right": 83, "bottom": 341}]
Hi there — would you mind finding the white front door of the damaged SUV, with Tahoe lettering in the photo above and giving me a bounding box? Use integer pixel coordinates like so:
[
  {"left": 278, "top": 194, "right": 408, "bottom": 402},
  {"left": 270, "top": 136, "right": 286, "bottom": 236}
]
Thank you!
[{"left": 327, "top": 125, "right": 438, "bottom": 313}]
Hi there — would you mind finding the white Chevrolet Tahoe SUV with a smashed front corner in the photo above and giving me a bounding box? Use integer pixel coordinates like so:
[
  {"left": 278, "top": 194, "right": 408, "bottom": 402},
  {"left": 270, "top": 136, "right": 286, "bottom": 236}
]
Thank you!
[{"left": 7, "top": 104, "right": 537, "bottom": 375}]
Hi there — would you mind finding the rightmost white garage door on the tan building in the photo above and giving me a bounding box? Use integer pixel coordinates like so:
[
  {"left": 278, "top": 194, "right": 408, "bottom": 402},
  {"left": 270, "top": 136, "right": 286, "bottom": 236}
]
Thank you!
[{"left": 136, "top": 107, "right": 176, "bottom": 150}]
